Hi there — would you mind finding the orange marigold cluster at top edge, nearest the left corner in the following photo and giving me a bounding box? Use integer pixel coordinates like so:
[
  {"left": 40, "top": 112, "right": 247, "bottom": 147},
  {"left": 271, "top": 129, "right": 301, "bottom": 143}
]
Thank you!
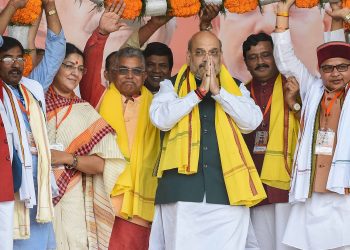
[{"left": 11, "top": 0, "right": 41, "bottom": 25}]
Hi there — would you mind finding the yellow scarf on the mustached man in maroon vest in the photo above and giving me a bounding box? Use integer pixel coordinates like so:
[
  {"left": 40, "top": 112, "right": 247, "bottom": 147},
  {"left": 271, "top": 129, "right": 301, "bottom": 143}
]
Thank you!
[{"left": 260, "top": 74, "right": 299, "bottom": 190}]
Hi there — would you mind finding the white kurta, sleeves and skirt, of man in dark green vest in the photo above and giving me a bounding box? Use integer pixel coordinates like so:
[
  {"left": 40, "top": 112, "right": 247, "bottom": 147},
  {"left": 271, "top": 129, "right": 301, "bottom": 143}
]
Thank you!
[{"left": 149, "top": 76, "right": 262, "bottom": 250}]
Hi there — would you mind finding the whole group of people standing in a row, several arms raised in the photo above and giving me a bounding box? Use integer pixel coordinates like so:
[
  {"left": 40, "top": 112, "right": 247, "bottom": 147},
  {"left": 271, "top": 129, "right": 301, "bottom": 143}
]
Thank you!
[{"left": 0, "top": 0, "right": 350, "bottom": 250}]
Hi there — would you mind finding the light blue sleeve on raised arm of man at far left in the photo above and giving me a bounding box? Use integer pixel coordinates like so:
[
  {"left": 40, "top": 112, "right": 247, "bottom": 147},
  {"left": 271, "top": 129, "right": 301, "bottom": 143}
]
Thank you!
[{"left": 29, "top": 29, "right": 66, "bottom": 91}]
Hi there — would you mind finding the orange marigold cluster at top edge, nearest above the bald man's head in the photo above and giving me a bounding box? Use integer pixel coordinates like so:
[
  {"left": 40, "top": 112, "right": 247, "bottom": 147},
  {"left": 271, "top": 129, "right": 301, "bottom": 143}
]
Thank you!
[{"left": 168, "top": 0, "right": 201, "bottom": 17}]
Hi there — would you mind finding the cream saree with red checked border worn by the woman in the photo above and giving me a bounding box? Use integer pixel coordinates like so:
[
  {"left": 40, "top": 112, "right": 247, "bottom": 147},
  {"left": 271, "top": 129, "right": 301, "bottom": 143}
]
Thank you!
[{"left": 46, "top": 91, "right": 125, "bottom": 249}]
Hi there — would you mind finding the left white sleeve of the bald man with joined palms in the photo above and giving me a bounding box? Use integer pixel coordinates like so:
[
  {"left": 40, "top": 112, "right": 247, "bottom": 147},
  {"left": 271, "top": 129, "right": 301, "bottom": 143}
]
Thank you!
[{"left": 150, "top": 80, "right": 200, "bottom": 131}]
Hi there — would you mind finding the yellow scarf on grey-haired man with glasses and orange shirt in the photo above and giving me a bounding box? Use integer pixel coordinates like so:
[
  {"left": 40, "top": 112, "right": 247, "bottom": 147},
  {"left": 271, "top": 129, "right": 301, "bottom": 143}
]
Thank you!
[{"left": 99, "top": 84, "right": 160, "bottom": 221}]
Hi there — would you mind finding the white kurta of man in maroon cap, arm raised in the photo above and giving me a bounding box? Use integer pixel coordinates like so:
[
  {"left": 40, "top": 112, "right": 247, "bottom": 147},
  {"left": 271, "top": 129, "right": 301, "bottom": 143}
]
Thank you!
[{"left": 272, "top": 30, "right": 350, "bottom": 250}]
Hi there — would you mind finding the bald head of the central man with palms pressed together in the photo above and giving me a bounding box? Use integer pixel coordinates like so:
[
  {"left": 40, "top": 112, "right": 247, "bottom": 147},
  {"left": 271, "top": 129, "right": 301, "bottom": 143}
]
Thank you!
[{"left": 187, "top": 31, "right": 222, "bottom": 79}]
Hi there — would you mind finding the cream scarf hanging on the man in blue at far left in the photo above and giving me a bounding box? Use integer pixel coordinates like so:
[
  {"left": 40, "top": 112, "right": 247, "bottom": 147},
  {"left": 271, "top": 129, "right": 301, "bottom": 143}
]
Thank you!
[{"left": 14, "top": 85, "right": 54, "bottom": 239}]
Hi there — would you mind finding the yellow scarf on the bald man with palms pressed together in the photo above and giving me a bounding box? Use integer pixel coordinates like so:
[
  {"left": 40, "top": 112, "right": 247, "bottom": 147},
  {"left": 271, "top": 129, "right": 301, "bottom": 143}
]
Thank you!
[{"left": 157, "top": 65, "right": 266, "bottom": 207}]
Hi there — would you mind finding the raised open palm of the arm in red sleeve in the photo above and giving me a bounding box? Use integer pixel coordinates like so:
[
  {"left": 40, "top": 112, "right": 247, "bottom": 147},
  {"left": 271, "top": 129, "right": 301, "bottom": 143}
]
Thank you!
[{"left": 98, "top": 0, "right": 125, "bottom": 35}]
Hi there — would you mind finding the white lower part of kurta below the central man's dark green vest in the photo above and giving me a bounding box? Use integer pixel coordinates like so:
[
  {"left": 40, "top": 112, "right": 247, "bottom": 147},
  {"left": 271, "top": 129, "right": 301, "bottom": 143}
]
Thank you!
[{"left": 149, "top": 201, "right": 249, "bottom": 250}]
